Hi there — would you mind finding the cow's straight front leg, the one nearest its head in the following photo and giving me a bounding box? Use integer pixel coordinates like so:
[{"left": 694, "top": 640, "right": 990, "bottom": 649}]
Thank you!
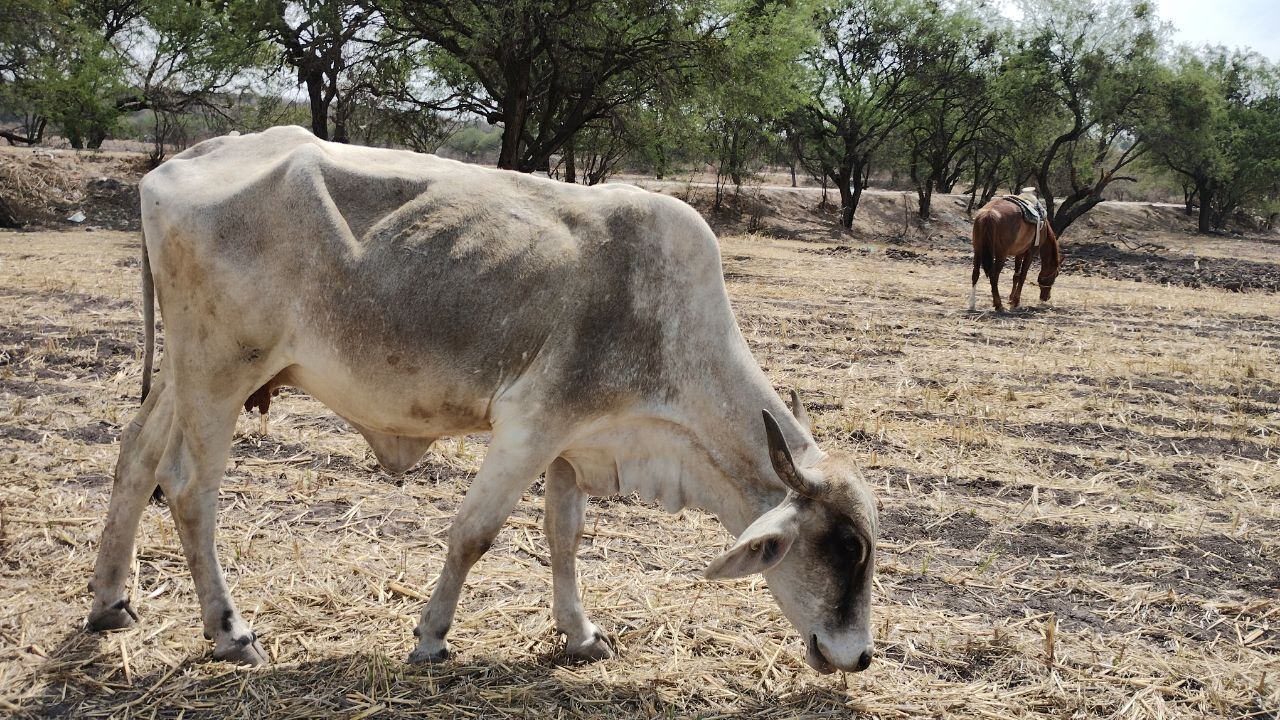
[{"left": 545, "top": 459, "right": 613, "bottom": 660}]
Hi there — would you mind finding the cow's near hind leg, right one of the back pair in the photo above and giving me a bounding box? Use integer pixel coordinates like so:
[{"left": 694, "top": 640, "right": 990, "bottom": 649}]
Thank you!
[{"left": 156, "top": 394, "right": 266, "bottom": 665}]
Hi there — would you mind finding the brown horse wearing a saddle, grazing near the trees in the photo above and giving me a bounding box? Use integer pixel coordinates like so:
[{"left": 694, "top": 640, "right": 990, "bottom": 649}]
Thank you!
[{"left": 969, "top": 197, "right": 1062, "bottom": 313}]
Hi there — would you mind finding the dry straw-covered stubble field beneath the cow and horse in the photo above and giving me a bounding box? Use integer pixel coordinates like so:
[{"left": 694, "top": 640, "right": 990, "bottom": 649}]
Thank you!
[{"left": 0, "top": 225, "right": 1280, "bottom": 720}]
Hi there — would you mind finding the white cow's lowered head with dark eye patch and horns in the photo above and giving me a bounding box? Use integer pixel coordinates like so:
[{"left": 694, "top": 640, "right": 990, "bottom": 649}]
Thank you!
[{"left": 707, "top": 393, "right": 877, "bottom": 673}]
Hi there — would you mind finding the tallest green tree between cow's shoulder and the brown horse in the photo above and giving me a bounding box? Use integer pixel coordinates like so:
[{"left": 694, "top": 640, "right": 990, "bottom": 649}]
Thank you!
[{"left": 791, "top": 0, "right": 941, "bottom": 228}]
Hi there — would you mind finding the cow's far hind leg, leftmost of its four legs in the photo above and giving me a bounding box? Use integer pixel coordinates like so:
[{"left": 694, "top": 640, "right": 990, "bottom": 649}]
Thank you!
[{"left": 87, "top": 372, "right": 173, "bottom": 632}]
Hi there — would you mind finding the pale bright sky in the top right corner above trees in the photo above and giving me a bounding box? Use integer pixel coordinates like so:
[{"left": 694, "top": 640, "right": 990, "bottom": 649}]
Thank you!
[{"left": 1155, "top": 0, "right": 1280, "bottom": 61}]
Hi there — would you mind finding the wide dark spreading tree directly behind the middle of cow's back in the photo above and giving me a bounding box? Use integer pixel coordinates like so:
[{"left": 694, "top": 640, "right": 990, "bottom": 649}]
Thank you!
[{"left": 380, "top": 0, "right": 722, "bottom": 172}]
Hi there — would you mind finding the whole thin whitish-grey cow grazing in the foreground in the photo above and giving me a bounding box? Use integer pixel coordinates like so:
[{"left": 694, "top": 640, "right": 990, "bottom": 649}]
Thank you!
[{"left": 88, "top": 128, "right": 877, "bottom": 673}]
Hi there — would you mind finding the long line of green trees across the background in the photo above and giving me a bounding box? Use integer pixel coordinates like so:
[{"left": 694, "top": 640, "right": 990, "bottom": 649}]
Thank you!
[{"left": 0, "top": 0, "right": 1280, "bottom": 233}]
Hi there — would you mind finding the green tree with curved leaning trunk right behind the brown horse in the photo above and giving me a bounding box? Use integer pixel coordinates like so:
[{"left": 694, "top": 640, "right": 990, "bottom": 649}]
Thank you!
[{"left": 1005, "top": 0, "right": 1160, "bottom": 236}]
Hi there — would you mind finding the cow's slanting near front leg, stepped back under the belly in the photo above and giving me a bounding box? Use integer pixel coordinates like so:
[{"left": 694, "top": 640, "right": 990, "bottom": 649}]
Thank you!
[{"left": 408, "top": 424, "right": 556, "bottom": 664}]
